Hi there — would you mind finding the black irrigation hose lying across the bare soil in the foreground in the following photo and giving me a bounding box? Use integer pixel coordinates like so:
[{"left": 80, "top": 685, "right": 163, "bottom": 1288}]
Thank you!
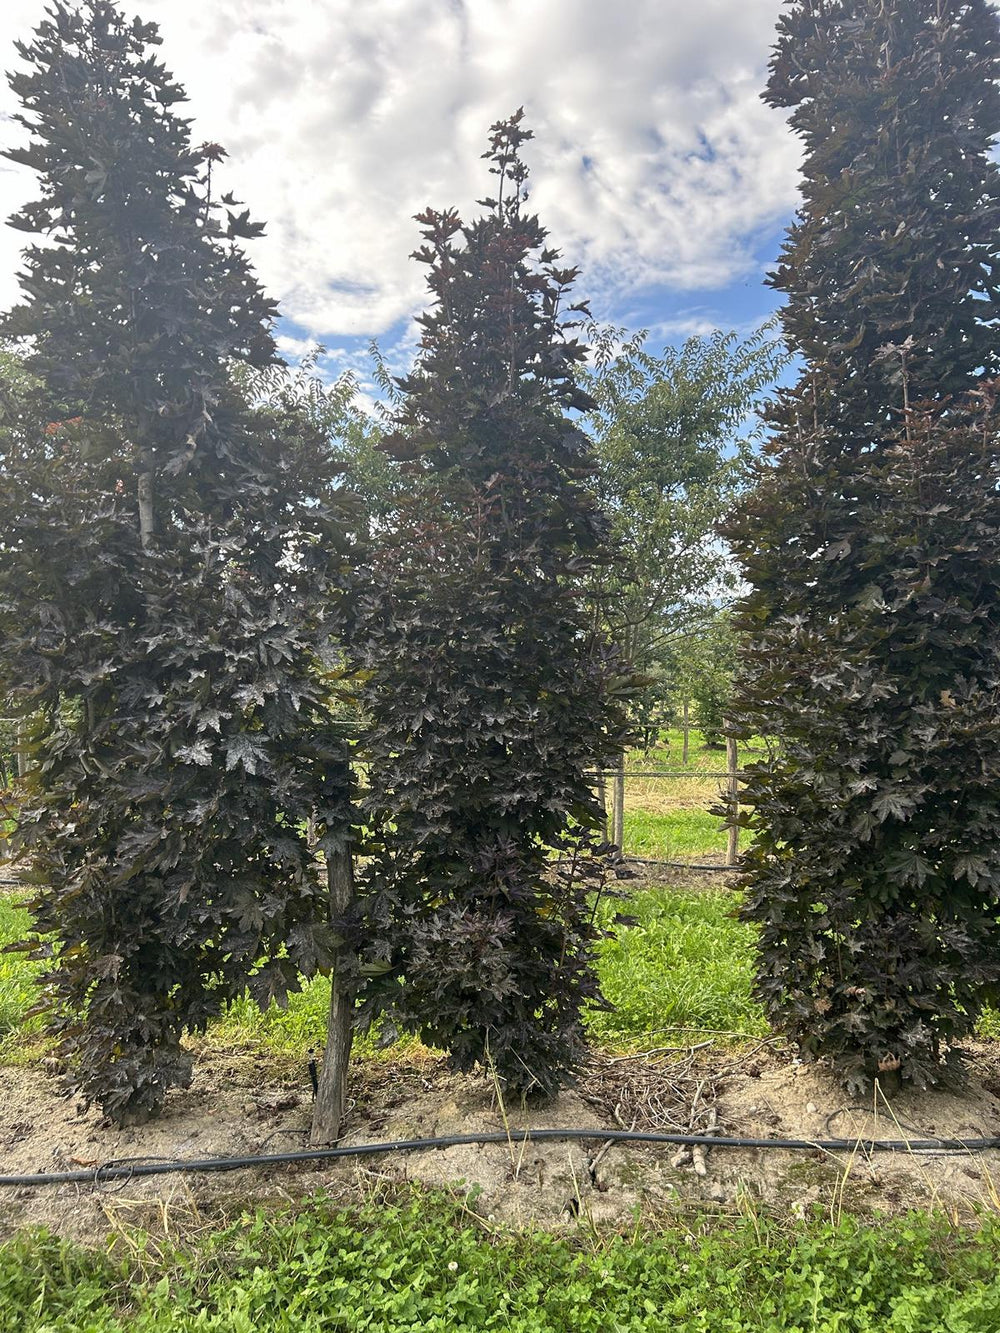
[{"left": 0, "top": 1129, "right": 1000, "bottom": 1186}]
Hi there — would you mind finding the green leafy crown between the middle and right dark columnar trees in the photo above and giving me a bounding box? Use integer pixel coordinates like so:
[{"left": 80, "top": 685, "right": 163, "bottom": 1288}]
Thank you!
[{"left": 581, "top": 319, "right": 788, "bottom": 741}]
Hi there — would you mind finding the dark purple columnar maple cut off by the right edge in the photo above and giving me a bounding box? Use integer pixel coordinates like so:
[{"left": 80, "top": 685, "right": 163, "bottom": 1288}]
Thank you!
[{"left": 729, "top": 0, "right": 1000, "bottom": 1085}]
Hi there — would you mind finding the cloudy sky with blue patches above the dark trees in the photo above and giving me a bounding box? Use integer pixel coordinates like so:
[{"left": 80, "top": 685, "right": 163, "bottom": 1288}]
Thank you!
[{"left": 0, "top": 0, "right": 799, "bottom": 383}]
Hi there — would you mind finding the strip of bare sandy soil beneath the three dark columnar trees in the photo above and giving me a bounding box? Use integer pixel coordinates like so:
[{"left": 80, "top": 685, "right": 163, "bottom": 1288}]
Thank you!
[{"left": 0, "top": 1044, "right": 1000, "bottom": 1240}]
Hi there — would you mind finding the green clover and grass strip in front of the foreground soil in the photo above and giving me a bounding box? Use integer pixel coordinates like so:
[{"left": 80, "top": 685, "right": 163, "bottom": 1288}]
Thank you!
[{"left": 0, "top": 1194, "right": 1000, "bottom": 1333}]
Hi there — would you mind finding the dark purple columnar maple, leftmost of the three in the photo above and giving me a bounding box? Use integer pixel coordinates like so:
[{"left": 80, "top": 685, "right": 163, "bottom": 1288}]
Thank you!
[{"left": 0, "top": 0, "right": 347, "bottom": 1121}]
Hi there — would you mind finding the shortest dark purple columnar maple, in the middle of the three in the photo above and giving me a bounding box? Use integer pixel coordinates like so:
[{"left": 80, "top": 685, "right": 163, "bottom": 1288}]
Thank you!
[{"left": 359, "top": 113, "right": 625, "bottom": 1092}]
